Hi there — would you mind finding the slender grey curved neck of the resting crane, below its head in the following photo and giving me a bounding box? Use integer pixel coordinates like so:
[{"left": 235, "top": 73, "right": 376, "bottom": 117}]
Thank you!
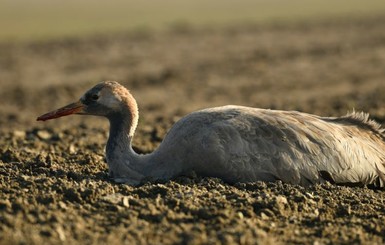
[{"left": 106, "top": 108, "right": 182, "bottom": 185}]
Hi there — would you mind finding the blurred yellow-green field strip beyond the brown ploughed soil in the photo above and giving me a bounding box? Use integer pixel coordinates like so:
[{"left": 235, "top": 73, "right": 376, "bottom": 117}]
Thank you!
[{"left": 0, "top": 0, "right": 385, "bottom": 41}]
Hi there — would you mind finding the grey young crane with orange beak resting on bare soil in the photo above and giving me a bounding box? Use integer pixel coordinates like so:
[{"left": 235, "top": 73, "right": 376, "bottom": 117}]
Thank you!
[{"left": 37, "top": 81, "right": 385, "bottom": 188}]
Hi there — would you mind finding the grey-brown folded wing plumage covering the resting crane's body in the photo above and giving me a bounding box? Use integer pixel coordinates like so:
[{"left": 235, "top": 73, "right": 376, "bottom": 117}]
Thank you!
[{"left": 162, "top": 106, "right": 385, "bottom": 185}]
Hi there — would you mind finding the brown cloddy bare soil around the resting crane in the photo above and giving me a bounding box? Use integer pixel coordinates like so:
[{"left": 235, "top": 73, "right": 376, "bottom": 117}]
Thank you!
[{"left": 0, "top": 16, "right": 385, "bottom": 244}]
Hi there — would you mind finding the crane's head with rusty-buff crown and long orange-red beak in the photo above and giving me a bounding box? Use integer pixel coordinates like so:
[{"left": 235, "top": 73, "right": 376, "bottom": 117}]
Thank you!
[{"left": 37, "top": 81, "right": 138, "bottom": 121}]
